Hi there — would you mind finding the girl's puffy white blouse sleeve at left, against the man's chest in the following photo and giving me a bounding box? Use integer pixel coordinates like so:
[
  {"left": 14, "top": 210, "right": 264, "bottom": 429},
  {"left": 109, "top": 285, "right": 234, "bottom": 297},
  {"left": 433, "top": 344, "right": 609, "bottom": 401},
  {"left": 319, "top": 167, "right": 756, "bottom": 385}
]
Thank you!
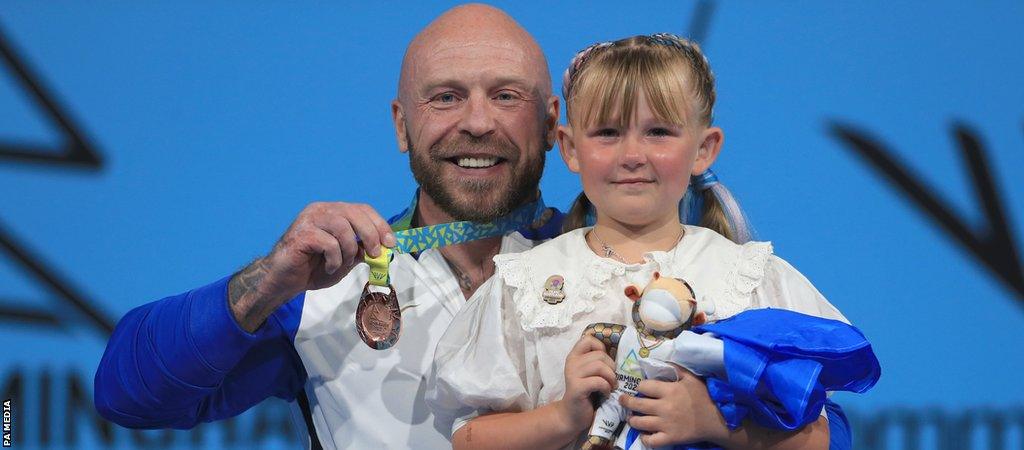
[{"left": 426, "top": 270, "right": 540, "bottom": 438}]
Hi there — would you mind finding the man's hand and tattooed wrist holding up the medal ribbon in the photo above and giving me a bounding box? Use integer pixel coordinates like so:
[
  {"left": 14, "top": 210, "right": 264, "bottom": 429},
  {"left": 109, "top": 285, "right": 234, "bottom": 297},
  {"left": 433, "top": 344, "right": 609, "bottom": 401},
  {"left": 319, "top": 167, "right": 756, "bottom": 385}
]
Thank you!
[{"left": 227, "top": 202, "right": 395, "bottom": 332}]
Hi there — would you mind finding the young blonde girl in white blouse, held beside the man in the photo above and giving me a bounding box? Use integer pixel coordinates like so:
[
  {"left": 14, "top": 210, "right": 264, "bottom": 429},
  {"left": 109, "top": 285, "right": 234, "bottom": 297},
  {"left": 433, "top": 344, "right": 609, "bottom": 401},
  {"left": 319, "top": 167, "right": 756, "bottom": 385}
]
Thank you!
[{"left": 427, "top": 34, "right": 864, "bottom": 449}]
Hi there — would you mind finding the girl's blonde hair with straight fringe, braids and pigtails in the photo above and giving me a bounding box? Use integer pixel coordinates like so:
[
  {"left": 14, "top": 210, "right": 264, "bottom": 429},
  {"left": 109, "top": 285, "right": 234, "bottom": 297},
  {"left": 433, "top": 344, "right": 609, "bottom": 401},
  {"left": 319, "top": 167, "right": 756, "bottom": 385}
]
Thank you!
[{"left": 562, "top": 33, "right": 737, "bottom": 241}]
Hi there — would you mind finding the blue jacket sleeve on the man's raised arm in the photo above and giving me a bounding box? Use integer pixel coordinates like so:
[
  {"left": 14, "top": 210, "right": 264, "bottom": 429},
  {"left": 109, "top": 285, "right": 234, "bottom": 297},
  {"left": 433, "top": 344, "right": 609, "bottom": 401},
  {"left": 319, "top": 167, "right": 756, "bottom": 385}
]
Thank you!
[{"left": 94, "top": 277, "right": 306, "bottom": 428}]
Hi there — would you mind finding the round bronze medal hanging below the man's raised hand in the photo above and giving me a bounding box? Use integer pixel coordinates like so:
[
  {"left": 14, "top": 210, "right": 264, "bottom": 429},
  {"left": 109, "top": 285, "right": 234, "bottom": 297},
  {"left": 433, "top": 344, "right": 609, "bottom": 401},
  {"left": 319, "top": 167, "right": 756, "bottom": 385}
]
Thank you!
[{"left": 355, "top": 283, "right": 401, "bottom": 350}]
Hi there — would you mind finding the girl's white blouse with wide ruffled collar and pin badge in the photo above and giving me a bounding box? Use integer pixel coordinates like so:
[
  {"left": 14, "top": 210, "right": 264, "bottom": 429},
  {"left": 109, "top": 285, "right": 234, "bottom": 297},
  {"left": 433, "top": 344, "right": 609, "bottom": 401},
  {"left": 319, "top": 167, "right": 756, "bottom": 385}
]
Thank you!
[{"left": 426, "top": 226, "right": 847, "bottom": 444}]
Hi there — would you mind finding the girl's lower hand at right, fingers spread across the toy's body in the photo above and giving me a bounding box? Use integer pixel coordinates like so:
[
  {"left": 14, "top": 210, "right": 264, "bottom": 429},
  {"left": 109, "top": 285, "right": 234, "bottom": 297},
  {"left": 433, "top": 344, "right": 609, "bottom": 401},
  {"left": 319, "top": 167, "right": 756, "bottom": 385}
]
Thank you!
[{"left": 620, "top": 367, "right": 729, "bottom": 447}]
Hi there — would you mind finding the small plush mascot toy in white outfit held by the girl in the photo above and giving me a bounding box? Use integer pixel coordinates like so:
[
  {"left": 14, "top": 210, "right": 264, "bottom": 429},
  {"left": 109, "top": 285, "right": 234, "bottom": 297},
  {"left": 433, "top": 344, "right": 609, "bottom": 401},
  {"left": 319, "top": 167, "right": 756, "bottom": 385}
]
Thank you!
[{"left": 583, "top": 272, "right": 708, "bottom": 450}]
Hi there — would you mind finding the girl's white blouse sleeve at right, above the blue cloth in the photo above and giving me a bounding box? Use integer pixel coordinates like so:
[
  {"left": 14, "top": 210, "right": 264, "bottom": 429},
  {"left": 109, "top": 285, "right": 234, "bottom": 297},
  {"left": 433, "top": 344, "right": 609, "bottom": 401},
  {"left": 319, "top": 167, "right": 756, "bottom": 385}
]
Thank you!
[{"left": 753, "top": 255, "right": 850, "bottom": 323}]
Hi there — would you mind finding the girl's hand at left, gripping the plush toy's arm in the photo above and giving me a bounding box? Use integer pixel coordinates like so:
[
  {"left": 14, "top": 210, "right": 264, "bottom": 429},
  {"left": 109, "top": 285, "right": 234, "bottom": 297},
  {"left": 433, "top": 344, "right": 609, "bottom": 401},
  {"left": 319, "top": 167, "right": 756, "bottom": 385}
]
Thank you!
[{"left": 555, "top": 336, "right": 615, "bottom": 429}]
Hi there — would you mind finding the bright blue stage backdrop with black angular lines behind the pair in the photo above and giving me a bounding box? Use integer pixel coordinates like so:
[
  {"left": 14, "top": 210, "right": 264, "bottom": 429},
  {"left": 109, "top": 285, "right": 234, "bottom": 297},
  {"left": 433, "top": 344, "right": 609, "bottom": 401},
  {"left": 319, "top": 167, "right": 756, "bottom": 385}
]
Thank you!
[{"left": 0, "top": 1, "right": 1024, "bottom": 449}]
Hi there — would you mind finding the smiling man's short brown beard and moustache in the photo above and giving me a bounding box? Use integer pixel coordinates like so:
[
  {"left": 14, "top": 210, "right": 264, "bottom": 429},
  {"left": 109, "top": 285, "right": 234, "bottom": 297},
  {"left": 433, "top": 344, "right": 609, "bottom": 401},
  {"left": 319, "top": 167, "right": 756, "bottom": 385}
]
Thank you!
[{"left": 406, "top": 133, "right": 545, "bottom": 222}]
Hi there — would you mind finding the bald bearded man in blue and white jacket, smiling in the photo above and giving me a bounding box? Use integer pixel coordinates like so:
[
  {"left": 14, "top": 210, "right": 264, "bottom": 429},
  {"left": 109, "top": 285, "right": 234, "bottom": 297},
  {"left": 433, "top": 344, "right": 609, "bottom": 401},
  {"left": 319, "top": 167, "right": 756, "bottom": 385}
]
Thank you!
[{"left": 95, "top": 5, "right": 561, "bottom": 449}]
